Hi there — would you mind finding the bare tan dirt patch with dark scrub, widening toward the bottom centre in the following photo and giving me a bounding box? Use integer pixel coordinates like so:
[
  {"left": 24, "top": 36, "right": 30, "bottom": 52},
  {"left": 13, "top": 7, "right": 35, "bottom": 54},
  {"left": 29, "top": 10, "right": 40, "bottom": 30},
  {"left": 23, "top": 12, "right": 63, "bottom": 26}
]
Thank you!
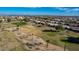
[{"left": 15, "top": 26, "right": 64, "bottom": 51}]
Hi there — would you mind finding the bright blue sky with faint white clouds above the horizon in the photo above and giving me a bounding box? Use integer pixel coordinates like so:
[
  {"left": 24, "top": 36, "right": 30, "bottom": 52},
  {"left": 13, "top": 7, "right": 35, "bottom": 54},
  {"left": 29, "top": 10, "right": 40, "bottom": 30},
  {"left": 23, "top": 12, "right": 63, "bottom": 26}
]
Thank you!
[{"left": 0, "top": 7, "right": 79, "bottom": 16}]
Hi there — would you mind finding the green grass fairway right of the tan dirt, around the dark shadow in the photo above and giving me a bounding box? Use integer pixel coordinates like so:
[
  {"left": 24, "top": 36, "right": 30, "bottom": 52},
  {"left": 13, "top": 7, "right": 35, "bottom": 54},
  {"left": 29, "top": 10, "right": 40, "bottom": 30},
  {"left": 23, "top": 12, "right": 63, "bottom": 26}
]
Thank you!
[{"left": 41, "top": 31, "right": 79, "bottom": 51}]
